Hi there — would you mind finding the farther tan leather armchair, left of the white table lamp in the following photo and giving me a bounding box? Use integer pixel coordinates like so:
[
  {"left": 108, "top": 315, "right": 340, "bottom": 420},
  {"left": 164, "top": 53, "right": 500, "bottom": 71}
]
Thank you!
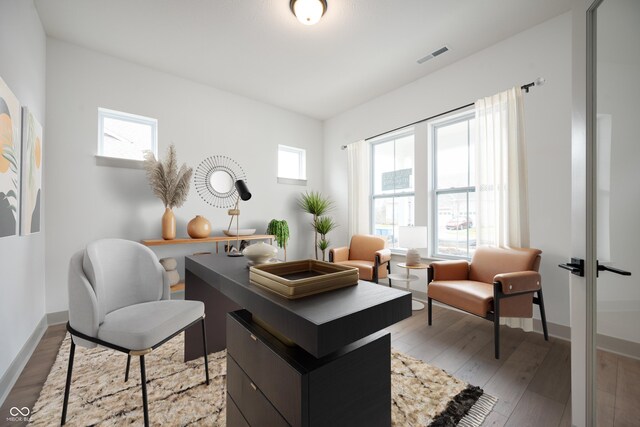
[{"left": 329, "top": 234, "right": 391, "bottom": 286}]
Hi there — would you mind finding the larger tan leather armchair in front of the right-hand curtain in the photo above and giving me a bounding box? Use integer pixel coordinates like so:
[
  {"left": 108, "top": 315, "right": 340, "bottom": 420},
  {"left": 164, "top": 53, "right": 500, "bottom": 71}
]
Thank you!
[{"left": 427, "top": 247, "right": 549, "bottom": 359}]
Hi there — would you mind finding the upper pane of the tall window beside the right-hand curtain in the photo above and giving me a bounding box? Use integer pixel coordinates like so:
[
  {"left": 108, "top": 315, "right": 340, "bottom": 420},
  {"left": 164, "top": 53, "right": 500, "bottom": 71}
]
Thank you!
[{"left": 435, "top": 120, "right": 469, "bottom": 189}]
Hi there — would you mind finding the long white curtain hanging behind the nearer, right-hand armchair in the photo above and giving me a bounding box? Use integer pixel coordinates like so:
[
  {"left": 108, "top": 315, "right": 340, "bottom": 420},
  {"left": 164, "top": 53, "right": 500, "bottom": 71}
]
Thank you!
[{"left": 475, "top": 87, "right": 533, "bottom": 331}]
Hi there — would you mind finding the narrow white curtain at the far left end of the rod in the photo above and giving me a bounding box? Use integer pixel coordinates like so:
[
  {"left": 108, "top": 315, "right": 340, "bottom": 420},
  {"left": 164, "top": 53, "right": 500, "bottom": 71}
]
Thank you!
[{"left": 347, "top": 140, "right": 371, "bottom": 237}]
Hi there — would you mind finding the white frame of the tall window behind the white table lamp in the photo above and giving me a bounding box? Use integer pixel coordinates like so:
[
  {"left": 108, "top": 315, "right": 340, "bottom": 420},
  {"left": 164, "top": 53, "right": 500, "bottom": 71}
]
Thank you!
[{"left": 369, "top": 126, "right": 417, "bottom": 250}]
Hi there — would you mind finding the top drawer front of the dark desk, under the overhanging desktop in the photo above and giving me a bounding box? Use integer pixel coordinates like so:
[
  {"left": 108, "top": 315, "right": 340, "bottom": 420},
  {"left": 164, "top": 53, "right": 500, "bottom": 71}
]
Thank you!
[{"left": 227, "top": 313, "right": 303, "bottom": 425}]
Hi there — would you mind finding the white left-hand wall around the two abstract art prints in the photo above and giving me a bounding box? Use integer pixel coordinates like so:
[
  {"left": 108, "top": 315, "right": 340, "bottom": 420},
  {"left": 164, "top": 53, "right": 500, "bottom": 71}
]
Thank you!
[{"left": 0, "top": 0, "right": 49, "bottom": 388}]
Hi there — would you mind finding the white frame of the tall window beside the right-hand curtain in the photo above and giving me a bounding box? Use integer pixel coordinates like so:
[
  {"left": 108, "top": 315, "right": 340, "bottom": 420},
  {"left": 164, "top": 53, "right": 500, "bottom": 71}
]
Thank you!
[{"left": 428, "top": 109, "right": 477, "bottom": 260}]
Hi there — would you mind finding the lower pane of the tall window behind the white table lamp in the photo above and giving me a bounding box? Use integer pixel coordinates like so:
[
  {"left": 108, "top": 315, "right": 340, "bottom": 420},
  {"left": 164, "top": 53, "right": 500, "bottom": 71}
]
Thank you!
[{"left": 373, "top": 196, "right": 415, "bottom": 248}]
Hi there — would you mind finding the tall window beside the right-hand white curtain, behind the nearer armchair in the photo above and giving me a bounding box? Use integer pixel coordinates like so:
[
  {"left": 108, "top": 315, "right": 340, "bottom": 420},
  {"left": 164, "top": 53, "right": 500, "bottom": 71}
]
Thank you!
[{"left": 430, "top": 112, "right": 476, "bottom": 258}]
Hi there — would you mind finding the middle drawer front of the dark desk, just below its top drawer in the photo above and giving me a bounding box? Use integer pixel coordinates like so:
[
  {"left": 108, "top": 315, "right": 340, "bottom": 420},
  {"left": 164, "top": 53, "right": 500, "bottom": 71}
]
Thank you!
[{"left": 227, "top": 356, "right": 289, "bottom": 427}]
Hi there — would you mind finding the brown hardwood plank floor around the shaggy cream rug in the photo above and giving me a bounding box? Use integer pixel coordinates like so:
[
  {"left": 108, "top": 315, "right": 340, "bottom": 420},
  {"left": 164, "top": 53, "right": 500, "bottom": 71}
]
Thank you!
[{"left": 0, "top": 306, "right": 640, "bottom": 427}]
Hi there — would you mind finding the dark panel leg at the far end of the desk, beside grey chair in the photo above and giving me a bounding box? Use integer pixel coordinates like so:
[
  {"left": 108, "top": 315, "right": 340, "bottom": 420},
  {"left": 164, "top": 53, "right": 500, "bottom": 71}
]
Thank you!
[{"left": 184, "top": 270, "right": 242, "bottom": 362}]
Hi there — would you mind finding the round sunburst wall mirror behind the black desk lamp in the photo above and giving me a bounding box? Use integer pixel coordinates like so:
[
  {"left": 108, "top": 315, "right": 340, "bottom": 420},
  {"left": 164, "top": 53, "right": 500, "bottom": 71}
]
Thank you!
[{"left": 193, "top": 156, "right": 247, "bottom": 208}]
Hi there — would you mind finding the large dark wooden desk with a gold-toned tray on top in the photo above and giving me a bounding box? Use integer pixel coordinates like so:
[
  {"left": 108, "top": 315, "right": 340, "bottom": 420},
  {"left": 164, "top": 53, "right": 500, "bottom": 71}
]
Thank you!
[{"left": 185, "top": 254, "right": 411, "bottom": 427}]
